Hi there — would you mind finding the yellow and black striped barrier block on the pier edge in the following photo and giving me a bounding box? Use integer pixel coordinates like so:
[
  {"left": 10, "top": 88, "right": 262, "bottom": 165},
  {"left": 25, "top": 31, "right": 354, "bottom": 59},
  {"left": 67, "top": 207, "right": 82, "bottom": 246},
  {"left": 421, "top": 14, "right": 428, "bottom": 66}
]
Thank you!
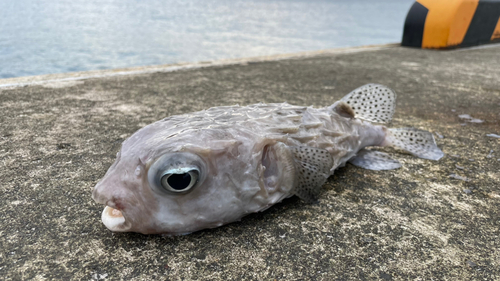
[{"left": 401, "top": 0, "right": 500, "bottom": 49}]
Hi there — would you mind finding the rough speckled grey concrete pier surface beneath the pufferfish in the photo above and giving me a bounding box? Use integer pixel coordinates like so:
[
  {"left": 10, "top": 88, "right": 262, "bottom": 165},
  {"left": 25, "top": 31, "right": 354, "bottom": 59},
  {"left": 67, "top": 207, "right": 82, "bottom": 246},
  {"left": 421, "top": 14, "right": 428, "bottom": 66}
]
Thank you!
[{"left": 0, "top": 46, "right": 500, "bottom": 280}]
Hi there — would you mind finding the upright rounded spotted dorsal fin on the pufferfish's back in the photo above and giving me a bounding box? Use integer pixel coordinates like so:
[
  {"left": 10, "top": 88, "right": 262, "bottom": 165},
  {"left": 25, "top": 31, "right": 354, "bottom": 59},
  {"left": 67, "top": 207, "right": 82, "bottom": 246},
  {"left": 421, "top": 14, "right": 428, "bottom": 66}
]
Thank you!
[{"left": 341, "top": 84, "right": 396, "bottom": 123}]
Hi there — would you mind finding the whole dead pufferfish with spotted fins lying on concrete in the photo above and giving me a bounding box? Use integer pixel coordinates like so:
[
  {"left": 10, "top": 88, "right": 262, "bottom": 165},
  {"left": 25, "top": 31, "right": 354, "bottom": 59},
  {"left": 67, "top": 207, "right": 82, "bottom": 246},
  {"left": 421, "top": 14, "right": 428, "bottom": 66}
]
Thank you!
[{"left": 92, "top": 84, "right": 443, "bottom": 235}]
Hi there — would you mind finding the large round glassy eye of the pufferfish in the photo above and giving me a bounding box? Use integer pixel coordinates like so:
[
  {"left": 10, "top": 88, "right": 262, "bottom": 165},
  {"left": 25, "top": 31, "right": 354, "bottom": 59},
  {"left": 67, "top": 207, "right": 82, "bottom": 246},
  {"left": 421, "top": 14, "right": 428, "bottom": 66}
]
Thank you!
[{"left": 147, "top": 152, "right": 207, "bottom": 195}]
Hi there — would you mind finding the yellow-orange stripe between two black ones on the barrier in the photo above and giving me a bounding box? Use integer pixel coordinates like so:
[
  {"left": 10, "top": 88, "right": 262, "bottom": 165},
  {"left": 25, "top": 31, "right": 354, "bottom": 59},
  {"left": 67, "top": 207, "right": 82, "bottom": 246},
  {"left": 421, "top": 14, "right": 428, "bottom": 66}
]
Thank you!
[{"left": 418, "top": 0, "right": 479, "bottom": 48}]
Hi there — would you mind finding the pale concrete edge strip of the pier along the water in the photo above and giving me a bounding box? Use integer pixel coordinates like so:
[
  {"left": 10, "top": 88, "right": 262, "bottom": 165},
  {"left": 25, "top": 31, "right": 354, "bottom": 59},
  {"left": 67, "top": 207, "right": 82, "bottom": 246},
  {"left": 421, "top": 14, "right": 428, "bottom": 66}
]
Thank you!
[{"left": 0, "top": 43, "right": 400, "bottom": 89}]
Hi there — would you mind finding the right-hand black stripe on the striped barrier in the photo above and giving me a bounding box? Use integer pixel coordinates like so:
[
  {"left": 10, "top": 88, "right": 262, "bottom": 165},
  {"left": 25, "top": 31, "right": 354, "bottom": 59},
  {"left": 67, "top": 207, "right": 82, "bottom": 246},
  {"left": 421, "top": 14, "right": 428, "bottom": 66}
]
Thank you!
[{"left": 460, "top": 0, "right": 500, "bottom": 47}]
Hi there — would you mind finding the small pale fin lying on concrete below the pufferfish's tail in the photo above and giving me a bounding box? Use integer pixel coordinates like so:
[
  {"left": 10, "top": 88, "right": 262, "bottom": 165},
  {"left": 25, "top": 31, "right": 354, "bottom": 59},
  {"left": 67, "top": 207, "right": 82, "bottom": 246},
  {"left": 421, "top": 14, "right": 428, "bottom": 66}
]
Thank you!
[{"left": 349, "top": 149, "right": 401, "bottom": 171}]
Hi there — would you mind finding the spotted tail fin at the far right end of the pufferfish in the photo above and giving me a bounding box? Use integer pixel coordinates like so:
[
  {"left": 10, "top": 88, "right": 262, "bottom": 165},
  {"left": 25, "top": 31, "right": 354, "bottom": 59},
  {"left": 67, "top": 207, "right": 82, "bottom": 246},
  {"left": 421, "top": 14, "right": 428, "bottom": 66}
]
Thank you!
[{"left": 383, "top": 128, "right": 444, "bottom": 160}]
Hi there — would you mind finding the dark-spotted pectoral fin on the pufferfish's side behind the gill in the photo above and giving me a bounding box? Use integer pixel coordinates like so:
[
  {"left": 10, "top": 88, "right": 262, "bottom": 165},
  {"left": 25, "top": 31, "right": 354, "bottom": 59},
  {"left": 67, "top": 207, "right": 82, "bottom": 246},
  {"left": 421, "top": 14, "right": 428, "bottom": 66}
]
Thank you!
[{"left": 290, "top": 146, "right": 333, "bottom": 203}]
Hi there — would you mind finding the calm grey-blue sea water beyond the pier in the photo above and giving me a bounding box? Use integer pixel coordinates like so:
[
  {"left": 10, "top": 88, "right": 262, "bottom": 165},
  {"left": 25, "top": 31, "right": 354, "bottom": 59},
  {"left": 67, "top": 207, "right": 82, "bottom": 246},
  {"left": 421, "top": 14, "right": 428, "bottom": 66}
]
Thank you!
[{"left": 0, "top": 0, "right": 414, "bottom": 78}]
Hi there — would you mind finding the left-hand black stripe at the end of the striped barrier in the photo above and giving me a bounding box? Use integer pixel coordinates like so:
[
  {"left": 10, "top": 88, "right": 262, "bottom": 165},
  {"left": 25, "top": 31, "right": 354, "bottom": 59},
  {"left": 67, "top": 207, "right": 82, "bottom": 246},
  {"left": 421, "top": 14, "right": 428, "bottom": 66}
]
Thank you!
[{"left": 401, "top": 2, "right": 429, "bottom": 47}]
